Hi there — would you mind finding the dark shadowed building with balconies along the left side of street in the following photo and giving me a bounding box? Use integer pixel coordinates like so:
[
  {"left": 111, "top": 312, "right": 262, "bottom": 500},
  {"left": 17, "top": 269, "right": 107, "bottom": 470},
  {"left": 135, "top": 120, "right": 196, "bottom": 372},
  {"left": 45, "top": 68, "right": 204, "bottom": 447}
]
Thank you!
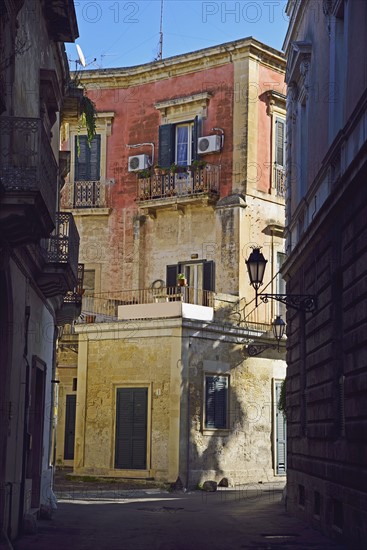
[{"left": 0, "top": 0, "right": 81, "bottom": 547}]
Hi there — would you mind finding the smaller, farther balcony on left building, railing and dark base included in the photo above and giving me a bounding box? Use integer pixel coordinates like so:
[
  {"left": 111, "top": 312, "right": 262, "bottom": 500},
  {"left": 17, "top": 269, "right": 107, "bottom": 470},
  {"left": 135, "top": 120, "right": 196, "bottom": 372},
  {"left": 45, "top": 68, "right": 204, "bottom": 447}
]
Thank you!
[{"left": 38, "top": 212, "right": 79, "bottom": 298}]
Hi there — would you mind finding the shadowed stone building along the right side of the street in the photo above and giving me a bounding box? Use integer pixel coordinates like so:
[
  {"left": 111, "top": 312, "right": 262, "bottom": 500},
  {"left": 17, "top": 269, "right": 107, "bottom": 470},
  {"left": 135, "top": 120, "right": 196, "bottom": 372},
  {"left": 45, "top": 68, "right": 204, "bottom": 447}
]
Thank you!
[{"left": 283, "top": 0, "right": 367, "bottom": 548}]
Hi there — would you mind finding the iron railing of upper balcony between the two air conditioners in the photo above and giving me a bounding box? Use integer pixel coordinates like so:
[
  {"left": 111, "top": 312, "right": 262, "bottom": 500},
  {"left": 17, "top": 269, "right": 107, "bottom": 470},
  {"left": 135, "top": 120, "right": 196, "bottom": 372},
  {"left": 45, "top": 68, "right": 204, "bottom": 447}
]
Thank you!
[{"left": 138, "top": 164, "right": 221, "bottom": 205}]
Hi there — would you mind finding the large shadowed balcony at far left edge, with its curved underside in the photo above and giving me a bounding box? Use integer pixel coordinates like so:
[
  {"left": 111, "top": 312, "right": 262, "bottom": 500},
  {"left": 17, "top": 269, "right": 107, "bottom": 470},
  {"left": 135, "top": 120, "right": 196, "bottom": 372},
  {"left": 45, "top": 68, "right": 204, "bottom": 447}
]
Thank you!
[{"left": 0, "top": 117, "right": 58, "bottom": 245}]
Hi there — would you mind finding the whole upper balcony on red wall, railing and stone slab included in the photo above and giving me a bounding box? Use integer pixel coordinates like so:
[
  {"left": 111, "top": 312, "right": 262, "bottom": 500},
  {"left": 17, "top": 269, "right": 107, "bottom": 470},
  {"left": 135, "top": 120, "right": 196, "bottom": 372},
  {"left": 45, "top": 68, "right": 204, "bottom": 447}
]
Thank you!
[{"left": 137, "top": 164, "right": 221, "bottom": 213}]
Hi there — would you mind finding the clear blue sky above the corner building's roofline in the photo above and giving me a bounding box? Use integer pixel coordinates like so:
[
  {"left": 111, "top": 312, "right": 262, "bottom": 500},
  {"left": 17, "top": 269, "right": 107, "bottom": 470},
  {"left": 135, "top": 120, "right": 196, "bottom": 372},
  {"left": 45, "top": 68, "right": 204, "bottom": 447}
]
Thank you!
[{"left": 67, "top": 0, "right": 287, "bottom": 69}]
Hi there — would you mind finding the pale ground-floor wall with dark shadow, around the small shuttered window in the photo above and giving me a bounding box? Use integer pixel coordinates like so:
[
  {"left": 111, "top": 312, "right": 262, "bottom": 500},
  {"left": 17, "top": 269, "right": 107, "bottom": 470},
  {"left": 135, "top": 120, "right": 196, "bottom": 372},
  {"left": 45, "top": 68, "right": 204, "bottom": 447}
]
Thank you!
[{"left": 180, "top": 339, "right": 272, "bottom": 488}]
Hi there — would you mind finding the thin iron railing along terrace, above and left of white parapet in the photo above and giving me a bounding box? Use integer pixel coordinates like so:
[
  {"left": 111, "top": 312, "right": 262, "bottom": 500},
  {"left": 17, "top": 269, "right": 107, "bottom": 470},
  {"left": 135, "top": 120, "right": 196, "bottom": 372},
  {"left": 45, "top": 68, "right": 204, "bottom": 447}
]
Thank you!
[{"left": 81, "top": 286, "right": 215, "bottom": 321}]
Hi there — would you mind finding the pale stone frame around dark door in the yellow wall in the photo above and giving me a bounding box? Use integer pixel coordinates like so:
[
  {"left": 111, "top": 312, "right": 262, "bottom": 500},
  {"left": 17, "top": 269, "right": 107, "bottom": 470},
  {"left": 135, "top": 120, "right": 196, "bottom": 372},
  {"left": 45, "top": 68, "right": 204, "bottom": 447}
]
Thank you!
[{"left": 110, "top": 382, "right": 154, "bottom": 478}]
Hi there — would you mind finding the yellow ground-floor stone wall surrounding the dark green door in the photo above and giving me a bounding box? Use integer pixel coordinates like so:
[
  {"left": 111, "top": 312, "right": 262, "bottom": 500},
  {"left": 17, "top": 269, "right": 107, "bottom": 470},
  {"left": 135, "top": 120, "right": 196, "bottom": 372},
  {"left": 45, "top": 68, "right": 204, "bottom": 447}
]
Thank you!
[{"left": 74, "top": 320, "right": 181, "bottom": 481}]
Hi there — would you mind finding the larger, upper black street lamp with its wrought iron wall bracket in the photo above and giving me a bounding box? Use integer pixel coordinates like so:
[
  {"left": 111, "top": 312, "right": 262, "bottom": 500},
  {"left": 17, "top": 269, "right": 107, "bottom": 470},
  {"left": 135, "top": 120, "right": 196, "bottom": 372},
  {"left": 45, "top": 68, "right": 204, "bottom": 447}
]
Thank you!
[{"left": 246, "top": 247, "right": 316, "bottom": 311}]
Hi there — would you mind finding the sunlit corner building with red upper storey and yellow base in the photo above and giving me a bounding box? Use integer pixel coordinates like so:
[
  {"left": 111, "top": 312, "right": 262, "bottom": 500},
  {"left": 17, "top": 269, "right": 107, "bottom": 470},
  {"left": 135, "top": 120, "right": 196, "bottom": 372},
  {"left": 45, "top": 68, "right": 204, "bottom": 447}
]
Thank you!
[{"left": 57, "top": 39, "right": 285, "bottom": 486}]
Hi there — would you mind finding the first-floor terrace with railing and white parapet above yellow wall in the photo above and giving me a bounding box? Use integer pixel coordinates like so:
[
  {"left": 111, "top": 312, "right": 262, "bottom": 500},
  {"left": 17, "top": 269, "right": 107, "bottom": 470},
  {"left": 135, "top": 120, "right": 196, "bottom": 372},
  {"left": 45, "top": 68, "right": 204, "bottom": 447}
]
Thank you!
[{"left": 81, "top": 286, "right": 215, "bottom": 323}]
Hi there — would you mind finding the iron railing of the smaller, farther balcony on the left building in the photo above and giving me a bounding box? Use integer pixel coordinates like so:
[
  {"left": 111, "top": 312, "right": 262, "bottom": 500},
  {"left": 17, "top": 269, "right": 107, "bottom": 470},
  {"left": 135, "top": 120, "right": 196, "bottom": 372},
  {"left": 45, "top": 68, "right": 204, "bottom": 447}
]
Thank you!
[{"left": 45, "top": 212, "right": 79, "bottom": 281}]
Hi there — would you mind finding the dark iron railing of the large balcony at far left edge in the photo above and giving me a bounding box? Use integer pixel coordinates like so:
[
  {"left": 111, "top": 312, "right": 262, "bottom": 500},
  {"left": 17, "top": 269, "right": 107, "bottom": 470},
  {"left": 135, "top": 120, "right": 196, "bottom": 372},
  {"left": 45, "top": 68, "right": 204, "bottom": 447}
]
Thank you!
[{"left": 0, "top": 117, "right": 58, "bottom": 220}]
